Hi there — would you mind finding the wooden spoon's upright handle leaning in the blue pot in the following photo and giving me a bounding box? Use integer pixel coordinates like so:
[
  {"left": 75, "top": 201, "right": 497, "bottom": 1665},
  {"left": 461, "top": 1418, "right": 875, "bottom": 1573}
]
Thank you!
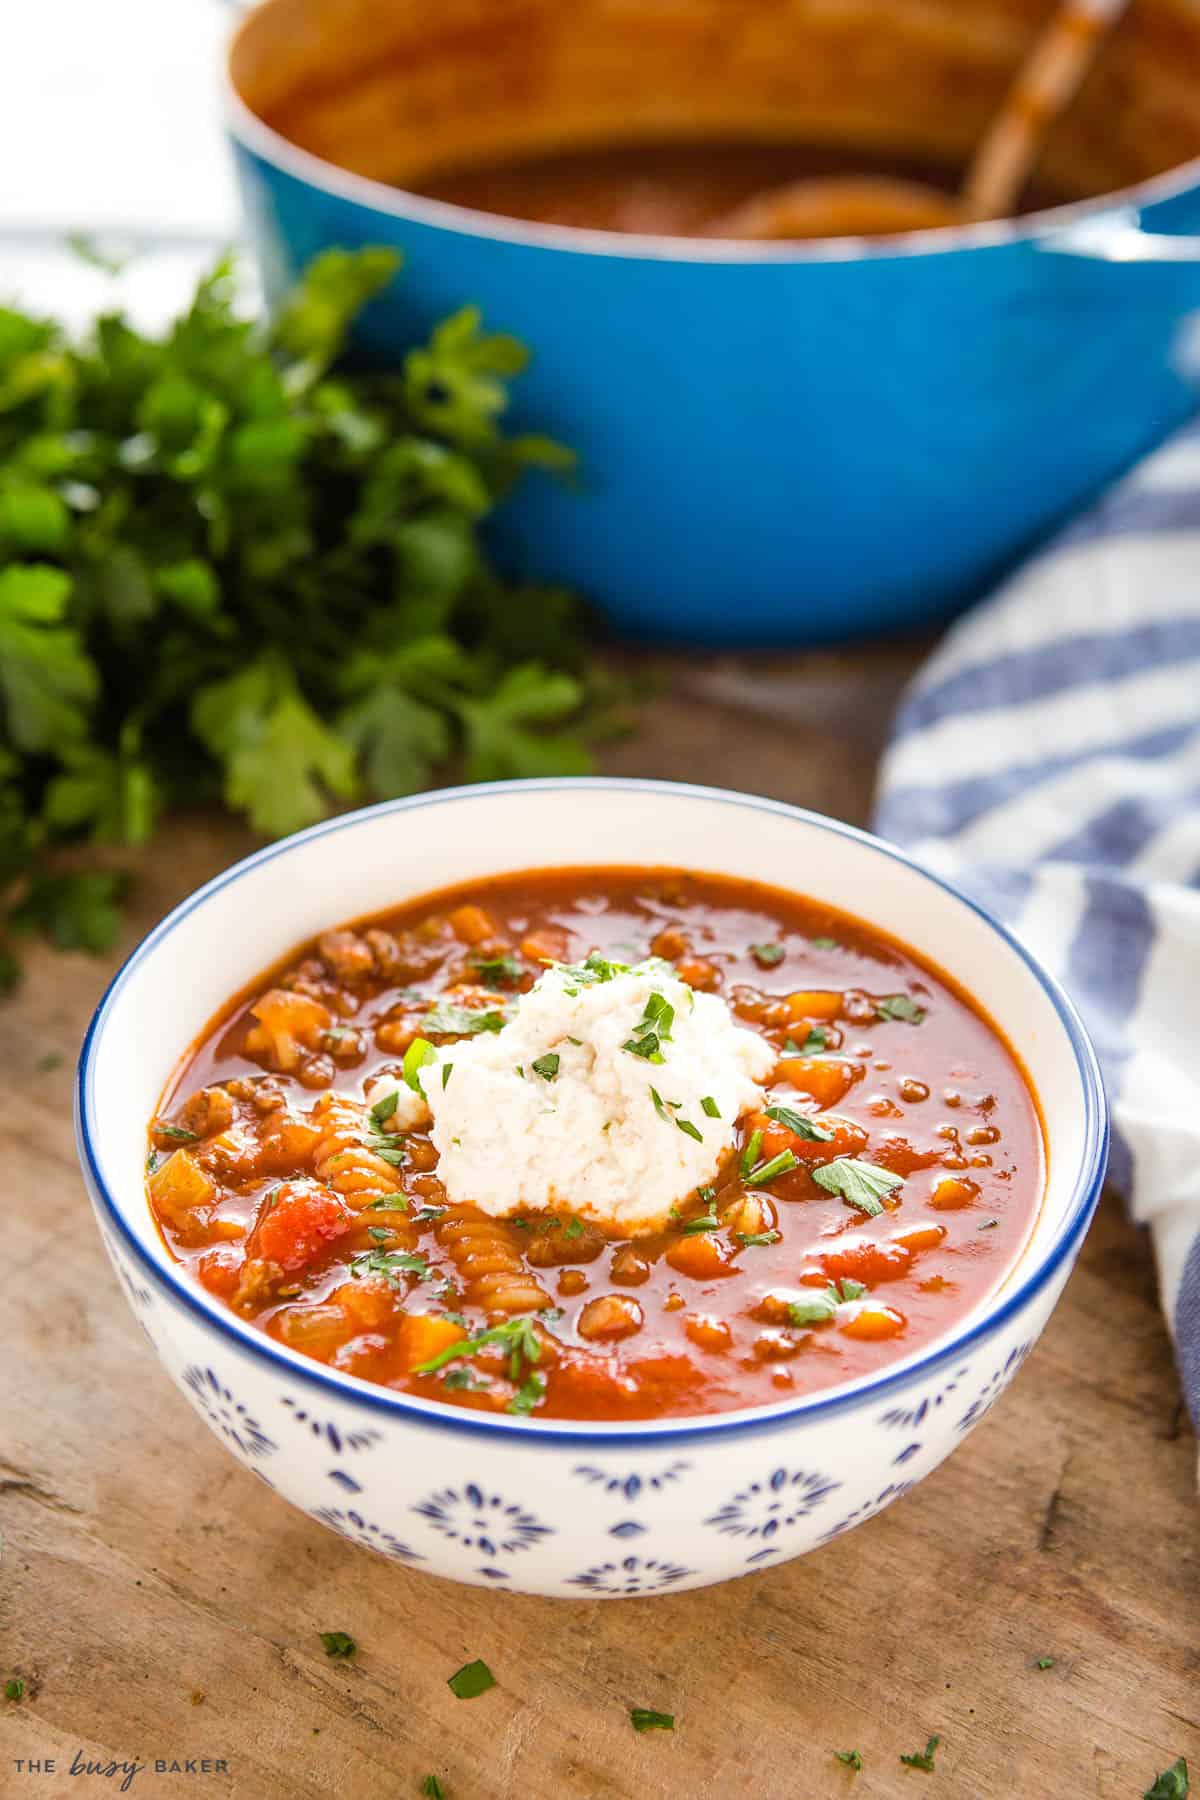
[{"left": 963, "top": 0, "right": 1130, "bottom": 220}]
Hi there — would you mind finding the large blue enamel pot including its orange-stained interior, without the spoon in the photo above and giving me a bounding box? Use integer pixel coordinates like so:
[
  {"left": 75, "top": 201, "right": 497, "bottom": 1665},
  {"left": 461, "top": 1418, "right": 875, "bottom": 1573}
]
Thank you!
[{"left": 228, "top": 0, "right": 1200, "bottom": 644}]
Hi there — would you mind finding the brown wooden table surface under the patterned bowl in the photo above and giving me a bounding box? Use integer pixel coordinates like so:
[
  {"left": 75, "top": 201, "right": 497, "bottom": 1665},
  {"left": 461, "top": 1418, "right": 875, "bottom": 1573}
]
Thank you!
[{"left": 0, "top": 648, "right": 1200, "bottom": 1800}]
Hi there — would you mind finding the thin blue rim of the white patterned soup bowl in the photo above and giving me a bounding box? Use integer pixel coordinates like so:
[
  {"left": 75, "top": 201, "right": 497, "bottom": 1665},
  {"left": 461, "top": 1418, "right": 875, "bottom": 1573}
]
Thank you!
[{"left": 76, "top": 776, "right": 1108, "bottom": 1449}]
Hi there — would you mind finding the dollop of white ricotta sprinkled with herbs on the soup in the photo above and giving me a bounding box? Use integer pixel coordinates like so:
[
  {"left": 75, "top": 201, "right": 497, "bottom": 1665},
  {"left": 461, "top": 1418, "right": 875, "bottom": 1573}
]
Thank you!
[{"left": 408, "top": 961, "right": 775, "bottom": 1235}]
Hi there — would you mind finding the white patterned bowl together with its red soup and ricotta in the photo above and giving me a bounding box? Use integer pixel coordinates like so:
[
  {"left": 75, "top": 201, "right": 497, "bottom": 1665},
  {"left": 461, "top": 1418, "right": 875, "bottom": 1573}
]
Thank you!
[{"left": 77, "top": 779, "right": 1106, "bottom": 1597}]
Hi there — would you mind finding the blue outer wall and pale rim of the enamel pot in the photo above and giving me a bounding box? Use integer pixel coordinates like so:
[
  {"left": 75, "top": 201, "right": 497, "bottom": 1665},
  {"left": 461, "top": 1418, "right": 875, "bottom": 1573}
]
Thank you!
[{"left": 228, "top": 0, "right": 1200, "bottom": 644}]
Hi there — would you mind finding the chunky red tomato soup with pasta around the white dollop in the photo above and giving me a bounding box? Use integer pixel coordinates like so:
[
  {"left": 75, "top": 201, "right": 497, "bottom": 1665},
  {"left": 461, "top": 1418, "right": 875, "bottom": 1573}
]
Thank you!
[{"left": 148, "top": 869, "right": 1043, "bottom": 1420}]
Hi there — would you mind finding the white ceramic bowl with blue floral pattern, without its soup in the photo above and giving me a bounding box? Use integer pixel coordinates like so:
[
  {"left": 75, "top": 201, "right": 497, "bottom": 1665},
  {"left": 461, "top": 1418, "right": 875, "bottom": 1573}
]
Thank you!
[{"left": 76, "top": 779, "right": 1108, "bottom": 1597}]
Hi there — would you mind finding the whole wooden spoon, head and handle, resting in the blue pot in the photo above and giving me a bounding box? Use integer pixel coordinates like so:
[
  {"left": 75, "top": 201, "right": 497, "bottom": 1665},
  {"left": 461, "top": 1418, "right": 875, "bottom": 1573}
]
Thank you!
[{"left": 705, "top": 0, "right": 1130, "bottom": 238}]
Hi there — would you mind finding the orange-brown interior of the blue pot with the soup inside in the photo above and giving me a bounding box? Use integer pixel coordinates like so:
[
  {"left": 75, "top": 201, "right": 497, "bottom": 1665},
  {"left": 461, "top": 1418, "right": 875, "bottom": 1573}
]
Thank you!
[{"left": 230, "top": 0, "right": 1200, "bottom": 236}]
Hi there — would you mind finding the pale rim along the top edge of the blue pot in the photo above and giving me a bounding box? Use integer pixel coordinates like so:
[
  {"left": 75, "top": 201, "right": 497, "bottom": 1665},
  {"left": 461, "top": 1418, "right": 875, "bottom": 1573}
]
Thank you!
[{"left": 221, "top": 13, "right": 1200, "bottom": 268}]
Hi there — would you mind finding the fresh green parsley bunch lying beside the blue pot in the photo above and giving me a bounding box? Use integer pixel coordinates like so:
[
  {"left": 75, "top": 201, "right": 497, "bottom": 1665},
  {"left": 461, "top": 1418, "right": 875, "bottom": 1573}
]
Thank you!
[{"left": 0, "top": 248, "right": 597, "bottom": 985}]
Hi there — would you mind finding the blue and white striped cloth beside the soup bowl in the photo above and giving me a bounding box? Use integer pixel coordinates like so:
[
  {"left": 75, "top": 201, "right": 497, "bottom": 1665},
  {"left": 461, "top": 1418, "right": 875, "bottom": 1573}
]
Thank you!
[{"left": 874, "top": 425, "right": 1200, "bottom": 1429}]
